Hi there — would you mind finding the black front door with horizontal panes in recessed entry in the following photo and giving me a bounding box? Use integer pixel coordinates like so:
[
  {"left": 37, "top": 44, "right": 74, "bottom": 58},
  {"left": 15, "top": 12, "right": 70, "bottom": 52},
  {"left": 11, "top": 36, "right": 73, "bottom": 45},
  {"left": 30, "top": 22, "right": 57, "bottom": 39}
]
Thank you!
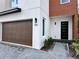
[{"left": 61, "top": 21, "right": 68, "bottom": 39}]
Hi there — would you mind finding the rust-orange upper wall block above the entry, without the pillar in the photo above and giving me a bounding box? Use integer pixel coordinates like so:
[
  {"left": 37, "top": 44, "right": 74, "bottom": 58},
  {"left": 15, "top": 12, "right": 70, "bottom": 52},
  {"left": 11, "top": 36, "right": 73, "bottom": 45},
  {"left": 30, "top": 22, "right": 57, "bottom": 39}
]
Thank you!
[{"left": 50, "top": 0, "right": 77, "bottom": 16}]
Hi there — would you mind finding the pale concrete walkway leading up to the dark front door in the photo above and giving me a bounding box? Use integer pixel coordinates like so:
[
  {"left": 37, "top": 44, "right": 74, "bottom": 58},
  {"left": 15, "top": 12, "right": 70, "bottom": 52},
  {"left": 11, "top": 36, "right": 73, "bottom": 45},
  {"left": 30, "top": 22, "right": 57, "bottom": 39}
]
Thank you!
[{"left": 48, "top": 43, "right": 71, "bottom": 59}]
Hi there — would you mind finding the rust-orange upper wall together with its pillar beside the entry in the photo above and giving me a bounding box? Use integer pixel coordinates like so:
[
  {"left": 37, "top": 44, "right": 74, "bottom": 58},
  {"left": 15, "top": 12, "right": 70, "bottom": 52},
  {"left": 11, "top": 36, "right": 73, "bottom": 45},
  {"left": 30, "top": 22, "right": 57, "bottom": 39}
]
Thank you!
[{"left": 49, "top": 0, "right": 78, "bottom": 39}]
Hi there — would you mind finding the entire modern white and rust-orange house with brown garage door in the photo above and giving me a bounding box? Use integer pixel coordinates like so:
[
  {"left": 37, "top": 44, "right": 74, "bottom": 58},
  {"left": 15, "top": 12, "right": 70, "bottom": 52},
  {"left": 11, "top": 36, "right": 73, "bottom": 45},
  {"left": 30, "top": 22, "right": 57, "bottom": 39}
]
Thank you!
[{"left": 0, "top": 0, "right": 78, "bottom": 49}]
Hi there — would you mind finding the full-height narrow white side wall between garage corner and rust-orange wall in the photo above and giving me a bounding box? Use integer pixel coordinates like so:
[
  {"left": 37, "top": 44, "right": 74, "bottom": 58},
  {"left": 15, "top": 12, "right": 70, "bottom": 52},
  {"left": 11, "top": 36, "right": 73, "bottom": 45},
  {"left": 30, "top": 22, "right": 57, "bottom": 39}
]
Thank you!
[{"left": 40, "top": 0, "right": 50, "bottom": 47}]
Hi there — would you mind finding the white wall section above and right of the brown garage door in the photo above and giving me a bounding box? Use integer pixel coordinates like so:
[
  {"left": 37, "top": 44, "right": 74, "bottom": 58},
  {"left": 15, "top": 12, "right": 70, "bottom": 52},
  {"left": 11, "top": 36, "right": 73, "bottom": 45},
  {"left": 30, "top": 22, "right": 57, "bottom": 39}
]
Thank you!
[{"left": 0, "top": 8, "right": 40, "bottom": 49}]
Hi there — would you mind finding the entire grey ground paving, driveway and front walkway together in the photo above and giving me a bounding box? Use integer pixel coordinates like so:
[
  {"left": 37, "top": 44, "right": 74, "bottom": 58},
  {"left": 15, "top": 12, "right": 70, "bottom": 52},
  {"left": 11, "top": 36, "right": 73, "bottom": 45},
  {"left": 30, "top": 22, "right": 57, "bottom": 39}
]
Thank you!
[{"left": 0, "top": 43, "right": 72, "bottom": 59}]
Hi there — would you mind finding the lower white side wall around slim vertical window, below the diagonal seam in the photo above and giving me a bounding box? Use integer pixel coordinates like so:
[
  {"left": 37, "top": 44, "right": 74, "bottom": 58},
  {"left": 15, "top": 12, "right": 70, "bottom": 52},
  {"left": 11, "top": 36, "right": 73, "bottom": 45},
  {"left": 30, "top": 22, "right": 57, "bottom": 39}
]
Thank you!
[{"left": 40, "top": 11, "right": 50, "bottom": 47}]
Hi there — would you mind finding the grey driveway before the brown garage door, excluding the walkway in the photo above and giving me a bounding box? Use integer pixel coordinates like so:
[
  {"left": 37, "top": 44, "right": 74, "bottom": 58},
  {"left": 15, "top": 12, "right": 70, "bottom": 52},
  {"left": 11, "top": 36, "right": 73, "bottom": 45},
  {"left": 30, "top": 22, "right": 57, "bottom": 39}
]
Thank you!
[{"left": 0, "top": 43, "right": 55, "bottom": 59}]
